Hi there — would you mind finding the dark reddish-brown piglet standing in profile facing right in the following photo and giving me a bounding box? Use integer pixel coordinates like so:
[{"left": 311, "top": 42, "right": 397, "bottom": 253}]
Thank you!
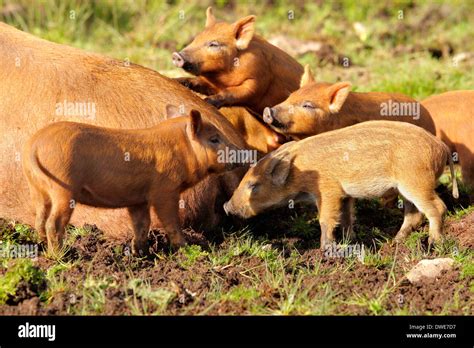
[{"left": 22, "top": 110, "right": 243, "bottom": 254}]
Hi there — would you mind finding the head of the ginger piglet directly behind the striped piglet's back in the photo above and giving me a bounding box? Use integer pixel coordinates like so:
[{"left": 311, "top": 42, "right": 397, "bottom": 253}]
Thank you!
[{"left": 263, "top": 65, "right": 351, "bottom": 139}]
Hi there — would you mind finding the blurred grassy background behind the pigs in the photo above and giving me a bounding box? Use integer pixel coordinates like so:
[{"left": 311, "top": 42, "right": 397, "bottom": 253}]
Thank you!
[{"left": 0, "top": 0, "right": 474, "bottom": 98}]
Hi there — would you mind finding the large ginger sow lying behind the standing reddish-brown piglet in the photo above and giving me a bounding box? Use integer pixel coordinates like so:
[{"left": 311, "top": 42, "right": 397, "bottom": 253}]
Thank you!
[{"left": 0, "top": 23, "right": 245, "bottom": 238}]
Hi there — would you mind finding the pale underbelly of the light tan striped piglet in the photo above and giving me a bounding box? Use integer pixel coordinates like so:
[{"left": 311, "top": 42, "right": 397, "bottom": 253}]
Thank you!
[{"left": 341, "top": 178, "right": 397, "bottom": 198}]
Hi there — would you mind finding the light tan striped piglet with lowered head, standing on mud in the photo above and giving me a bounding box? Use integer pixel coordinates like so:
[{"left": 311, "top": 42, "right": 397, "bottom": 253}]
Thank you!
[{"left": 224, "top": 121, "right": 458, "bottom": 248}]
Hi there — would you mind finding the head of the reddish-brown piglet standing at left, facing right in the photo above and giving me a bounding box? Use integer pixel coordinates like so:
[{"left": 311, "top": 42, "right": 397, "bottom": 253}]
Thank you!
[{"left": 166, "top": 105, "right": 242, "bottom": 173}]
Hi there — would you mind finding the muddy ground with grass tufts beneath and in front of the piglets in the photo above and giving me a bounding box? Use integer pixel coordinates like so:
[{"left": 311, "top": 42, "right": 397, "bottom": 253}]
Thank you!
[{"left": 0, "top": 190, "right": 474, "bottom": 315}]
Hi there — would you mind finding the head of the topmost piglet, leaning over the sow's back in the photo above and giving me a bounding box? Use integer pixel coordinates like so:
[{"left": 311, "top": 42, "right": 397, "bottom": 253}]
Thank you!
[{"left": 172, "top": 7, "right": 255, "bottom": 75}]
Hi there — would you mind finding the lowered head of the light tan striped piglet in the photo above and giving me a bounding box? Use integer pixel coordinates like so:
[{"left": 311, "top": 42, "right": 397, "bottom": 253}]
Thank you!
[{"left": 224, "top": 142, "right": 299, "bottom": 219}]
